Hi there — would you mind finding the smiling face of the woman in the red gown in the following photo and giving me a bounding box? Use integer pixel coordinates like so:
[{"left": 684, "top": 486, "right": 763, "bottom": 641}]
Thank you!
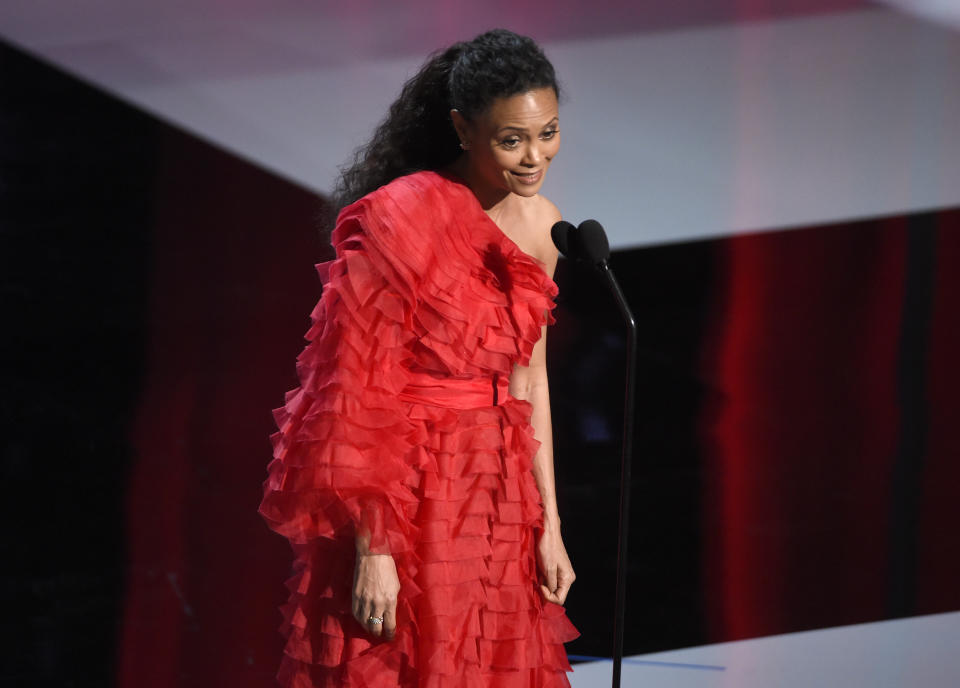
[{"left": 453, "top": 88, "right": 560, "bottom": 196}]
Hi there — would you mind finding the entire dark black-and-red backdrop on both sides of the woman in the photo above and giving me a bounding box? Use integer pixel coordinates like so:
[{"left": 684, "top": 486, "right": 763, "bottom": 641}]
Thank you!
[{"left": 0, "top": 40, "right": 960, "bottom": 688}]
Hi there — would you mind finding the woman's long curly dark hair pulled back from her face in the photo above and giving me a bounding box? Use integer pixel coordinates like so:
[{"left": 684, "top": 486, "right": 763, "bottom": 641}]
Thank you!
[{"left": 331, "top": 29, "right": 560, "bottom": 224}]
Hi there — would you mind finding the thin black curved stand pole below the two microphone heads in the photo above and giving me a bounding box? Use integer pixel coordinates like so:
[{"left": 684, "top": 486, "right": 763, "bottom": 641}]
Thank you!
[{"left": 597, "top": 260, "right": 637, "bottom": 688}]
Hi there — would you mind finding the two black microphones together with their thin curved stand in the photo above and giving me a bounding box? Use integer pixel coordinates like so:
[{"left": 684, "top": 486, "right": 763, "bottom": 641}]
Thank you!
[{"left": 551, "top": 220, "right": 637, "bottom": 688}]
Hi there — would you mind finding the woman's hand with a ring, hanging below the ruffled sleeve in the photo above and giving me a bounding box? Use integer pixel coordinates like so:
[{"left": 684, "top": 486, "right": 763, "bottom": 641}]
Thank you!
[{"left": 353, "top": 544, "right": 400, "bottom": 640}]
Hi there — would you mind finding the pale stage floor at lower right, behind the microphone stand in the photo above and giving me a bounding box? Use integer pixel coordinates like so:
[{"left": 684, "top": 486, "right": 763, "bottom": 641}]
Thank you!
[{"left": 570, "top": 612, "right": 960, "bottom": 688}]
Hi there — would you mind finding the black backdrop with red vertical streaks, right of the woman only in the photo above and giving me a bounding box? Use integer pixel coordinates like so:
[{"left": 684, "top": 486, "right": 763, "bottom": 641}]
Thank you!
[{"left": 550, "top": 210, "right": 960, "bottom": 656}]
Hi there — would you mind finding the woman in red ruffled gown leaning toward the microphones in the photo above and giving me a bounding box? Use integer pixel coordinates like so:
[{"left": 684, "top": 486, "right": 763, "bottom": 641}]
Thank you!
[{"left": 260, "top": 30, "right": 578, "bottom": 688}]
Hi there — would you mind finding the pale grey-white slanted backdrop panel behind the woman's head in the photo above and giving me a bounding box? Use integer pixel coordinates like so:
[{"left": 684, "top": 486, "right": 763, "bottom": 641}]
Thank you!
[{"left": 0, "top": 0, "right": 960, "bottom": 247}]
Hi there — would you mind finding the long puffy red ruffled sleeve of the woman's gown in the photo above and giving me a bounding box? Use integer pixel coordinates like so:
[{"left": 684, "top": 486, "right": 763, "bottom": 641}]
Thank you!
[{"left": 260, "top": 203, "right": 416, "bottom": 553}]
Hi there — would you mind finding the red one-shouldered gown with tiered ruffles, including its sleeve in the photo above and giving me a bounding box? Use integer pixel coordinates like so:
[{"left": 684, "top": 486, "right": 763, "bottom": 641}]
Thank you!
[{"left": 260, "top": 172, "right": 579, "bottom": 688}]
